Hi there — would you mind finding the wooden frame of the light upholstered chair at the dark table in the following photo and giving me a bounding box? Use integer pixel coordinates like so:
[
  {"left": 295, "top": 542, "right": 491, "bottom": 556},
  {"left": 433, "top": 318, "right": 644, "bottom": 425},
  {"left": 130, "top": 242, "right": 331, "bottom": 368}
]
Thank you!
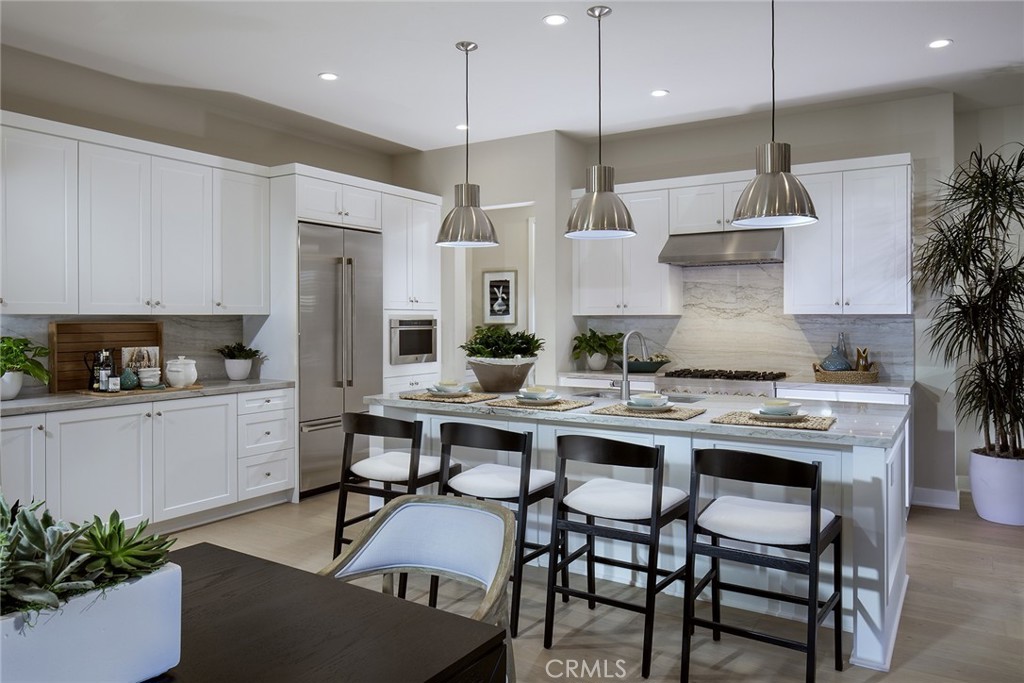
[{"left": 317, "top": 495, "right": 515, "bottom": 683}]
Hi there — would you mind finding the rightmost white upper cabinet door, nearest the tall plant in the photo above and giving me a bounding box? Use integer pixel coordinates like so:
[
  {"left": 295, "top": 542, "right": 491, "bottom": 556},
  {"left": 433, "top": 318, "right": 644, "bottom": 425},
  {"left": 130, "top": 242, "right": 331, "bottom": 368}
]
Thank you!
[{"left": 843, "top": 166, "right": 911, "bottom": 313}]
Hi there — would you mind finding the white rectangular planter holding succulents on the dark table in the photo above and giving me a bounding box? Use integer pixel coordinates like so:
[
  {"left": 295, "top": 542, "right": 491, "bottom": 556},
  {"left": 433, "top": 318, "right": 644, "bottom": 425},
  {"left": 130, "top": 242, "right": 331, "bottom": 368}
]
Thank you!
[{"left": 0, "top": 563, "right": 181, "bottom": 683}]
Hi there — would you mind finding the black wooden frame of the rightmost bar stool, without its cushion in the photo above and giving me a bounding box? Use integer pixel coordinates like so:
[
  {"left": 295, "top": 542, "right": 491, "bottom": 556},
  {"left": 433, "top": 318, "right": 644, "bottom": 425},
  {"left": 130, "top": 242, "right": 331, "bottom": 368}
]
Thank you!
[{"left": 680, "top": 449, "right": 843, "bottom": 683}]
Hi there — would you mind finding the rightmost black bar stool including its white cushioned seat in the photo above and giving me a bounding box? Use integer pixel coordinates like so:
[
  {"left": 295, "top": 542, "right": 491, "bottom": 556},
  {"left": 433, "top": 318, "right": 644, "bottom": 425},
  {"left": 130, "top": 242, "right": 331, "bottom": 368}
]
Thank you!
[{"left": 680, "top": 449, "right": 843, "bottom": 683}]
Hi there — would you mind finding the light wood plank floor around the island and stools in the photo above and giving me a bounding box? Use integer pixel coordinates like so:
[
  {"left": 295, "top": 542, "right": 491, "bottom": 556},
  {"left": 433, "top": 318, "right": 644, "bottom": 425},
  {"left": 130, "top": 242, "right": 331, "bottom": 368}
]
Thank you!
[{"left": 175, "top": 494, "right": 1024, "bottom": 683}]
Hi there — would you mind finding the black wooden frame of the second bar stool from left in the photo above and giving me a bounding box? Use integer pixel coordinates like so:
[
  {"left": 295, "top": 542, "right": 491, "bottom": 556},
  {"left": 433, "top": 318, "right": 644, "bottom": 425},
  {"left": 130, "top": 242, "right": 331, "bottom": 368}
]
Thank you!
[{"left": 439, "top": 422, "right": 555, "bottom": 638}]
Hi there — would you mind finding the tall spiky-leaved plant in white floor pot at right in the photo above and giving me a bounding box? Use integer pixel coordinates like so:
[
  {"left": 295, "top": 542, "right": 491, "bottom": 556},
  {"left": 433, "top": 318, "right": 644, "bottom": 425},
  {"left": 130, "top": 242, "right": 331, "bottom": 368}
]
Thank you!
[{"left": 915, "top": 142, "right": 1024, "bottom": 524}]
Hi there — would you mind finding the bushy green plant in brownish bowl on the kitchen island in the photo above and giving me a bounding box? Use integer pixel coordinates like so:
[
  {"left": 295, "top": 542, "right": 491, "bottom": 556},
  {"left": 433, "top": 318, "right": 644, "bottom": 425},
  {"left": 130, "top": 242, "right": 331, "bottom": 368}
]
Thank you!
[{"left": 459, "top": 325, "right": 544, "bottom": 392}]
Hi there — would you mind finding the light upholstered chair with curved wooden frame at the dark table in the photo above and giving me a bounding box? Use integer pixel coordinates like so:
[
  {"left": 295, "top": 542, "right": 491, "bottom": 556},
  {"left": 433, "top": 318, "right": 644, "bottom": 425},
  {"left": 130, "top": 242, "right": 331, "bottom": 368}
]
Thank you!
[{"left": 319, "top": 495, "right": 515, "bottom": 681}]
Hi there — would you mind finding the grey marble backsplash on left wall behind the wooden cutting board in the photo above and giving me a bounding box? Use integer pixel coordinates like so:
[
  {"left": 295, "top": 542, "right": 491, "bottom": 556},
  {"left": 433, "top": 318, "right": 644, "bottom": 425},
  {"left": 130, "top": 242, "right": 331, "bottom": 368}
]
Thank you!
[{"left": 0, "top": 315, "right": 242, "bottom": 396}]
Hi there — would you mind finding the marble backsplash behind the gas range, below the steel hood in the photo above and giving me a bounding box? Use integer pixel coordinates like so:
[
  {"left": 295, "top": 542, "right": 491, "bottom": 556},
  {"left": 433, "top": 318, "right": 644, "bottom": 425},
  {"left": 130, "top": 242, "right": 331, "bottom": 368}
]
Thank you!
[{"left": 586, "top": 264, "right": 914, "bottom": 381}]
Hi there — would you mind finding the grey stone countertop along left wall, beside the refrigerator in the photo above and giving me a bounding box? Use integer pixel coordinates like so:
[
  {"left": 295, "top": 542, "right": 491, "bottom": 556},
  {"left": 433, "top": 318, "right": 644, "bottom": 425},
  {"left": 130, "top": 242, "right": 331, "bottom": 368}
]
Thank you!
[{"left": 0, "top": 380, "right": 295, "bottom": 417}]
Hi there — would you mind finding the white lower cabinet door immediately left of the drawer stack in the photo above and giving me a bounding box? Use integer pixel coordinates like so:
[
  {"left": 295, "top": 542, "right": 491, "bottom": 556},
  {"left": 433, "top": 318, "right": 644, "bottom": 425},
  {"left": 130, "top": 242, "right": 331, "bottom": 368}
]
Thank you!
[{"left": 153, "top": 394, "right": 239, "bottom": 521}]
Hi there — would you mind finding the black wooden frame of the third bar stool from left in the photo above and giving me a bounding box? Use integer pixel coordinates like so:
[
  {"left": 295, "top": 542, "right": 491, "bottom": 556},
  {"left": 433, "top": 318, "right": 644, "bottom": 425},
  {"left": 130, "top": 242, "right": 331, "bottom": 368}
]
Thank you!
[{"left": 544, "top": 434, "right": 688, "bottom": 678}]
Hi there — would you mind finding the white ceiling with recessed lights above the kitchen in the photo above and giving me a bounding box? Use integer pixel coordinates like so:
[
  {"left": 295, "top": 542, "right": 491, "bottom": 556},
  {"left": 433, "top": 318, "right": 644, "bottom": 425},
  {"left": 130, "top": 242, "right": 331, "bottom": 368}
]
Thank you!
[{"left": 0, "top": 0, "right": 1024, "bottom": 150}]
